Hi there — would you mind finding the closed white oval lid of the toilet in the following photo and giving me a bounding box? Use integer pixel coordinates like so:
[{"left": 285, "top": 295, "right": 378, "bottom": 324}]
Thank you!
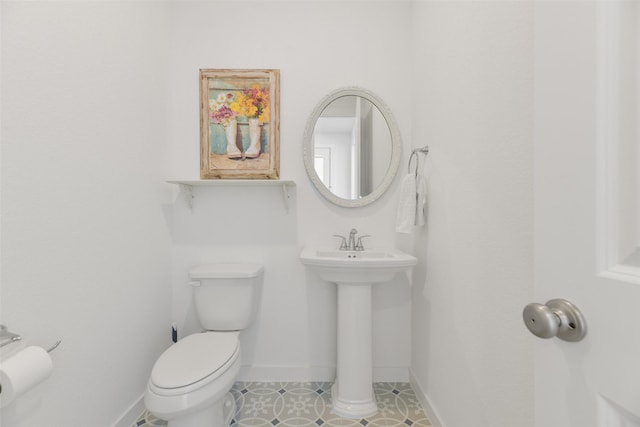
[{"left": 151, "top": 332, "right": 239, "bottom": 388}]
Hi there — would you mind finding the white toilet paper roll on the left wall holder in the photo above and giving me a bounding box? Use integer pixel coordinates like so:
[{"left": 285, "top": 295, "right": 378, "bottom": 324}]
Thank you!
[{"left": 0, "top": 346, "right": 53, "bottom": 408}]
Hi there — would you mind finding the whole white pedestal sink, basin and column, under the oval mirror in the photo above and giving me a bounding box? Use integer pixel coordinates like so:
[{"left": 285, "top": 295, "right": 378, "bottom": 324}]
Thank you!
[{"left": 300, "top": 247, "right": 418, "bottom": 418}]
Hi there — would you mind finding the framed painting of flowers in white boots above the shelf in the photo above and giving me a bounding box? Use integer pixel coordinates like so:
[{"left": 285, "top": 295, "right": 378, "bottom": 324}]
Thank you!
[{"left": 200, "top": 69, "right": 280, "bottom": 179}]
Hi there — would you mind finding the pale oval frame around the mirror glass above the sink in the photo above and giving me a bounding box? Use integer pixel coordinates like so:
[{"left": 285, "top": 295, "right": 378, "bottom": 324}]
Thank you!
[{"left": 302, "top": 87, "right": 402, "bottom": 208}]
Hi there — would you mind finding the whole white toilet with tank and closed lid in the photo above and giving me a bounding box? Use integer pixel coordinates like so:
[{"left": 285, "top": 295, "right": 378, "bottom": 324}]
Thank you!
[{"left": 144, "top": 263, "right": 263, "bottom": 427}]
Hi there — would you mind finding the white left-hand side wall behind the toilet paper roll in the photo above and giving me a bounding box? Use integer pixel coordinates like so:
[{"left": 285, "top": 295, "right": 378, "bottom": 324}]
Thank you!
[{"left": 0, "top": 1, "right": 170, "bottom": 427}]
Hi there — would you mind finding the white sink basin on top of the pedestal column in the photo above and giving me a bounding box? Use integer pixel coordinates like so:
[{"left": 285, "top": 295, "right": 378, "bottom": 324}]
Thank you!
[{"left": 300, "top": 247, "right": 418, "bottom": 284}]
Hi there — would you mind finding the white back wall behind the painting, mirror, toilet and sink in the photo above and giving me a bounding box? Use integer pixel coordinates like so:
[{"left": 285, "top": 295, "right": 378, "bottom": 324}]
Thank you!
[{"left": 167, "top": 1, "right": 412, "bottom": 380}]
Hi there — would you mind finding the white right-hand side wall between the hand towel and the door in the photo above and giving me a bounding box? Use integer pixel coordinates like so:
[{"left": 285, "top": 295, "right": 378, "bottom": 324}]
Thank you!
[{"left": 412, "top": 2, "right": 533, "bottom": 427}]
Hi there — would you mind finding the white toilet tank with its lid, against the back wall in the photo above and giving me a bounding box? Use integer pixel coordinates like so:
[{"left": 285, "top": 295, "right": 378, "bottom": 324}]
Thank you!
[{"left": 189, "top": 263, "right": 264, "bottom": 331}]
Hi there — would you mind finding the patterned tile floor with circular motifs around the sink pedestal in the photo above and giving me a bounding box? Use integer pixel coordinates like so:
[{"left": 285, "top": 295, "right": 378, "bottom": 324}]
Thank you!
[{"left": 137, "top": 382, "right": 431, "bottom": 427}]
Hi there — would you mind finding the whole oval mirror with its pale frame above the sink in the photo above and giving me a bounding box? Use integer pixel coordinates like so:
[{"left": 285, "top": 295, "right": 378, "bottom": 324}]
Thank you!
[{"left": 303, "top": 87, "right": 402, "bottom": 207}]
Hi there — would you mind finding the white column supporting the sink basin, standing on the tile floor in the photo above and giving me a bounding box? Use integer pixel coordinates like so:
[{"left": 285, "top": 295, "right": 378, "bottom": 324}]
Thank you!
[{"left": 331, "top": 282, "right": 378, "bottom": 418}]
